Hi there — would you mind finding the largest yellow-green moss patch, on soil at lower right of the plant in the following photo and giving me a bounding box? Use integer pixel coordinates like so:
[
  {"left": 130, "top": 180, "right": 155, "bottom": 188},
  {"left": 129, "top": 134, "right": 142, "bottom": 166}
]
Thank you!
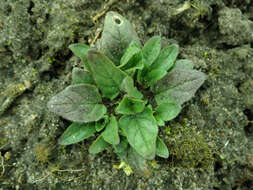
[{"left": 164, "top": 121, "right": 214, "bottom": 168}]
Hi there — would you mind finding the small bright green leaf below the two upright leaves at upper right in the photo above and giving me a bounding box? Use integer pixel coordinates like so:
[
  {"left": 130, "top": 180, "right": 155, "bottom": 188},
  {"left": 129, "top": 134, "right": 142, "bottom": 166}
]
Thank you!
[{"left": 144, "top": 69, "right": 167, "bottom": 88}]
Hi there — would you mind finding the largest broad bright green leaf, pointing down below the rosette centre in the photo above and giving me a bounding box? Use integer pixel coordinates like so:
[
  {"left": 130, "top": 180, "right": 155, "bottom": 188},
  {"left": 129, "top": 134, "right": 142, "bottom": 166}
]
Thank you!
[{"left": 119, "top": 108, "right": 158, "bottom": 159}]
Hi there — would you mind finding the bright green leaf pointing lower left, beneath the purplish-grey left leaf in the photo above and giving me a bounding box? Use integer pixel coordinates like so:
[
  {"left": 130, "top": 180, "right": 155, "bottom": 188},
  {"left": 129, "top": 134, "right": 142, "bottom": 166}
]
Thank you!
[{"left": 59, "top": 122, "right": 96, "bottom": 145}]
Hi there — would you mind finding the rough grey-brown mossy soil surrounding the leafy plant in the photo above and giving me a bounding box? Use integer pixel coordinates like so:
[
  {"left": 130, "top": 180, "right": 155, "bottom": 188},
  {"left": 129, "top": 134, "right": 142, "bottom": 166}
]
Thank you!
[{"left": 0, "top": 0, "right": 253, "bottom": 190}]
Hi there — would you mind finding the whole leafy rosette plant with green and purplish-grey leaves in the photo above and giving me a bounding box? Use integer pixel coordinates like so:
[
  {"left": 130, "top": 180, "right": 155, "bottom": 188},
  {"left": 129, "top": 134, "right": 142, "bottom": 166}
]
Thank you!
[{"left": 48, "top": 12, "right": 206, "bottom": 173}]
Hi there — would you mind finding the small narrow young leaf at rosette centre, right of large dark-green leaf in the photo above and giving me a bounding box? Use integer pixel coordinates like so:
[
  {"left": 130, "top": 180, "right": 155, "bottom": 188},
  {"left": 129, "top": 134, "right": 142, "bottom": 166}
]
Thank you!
[{"left": 121, "top": 76, "right": 143, "bottom": 99}]
